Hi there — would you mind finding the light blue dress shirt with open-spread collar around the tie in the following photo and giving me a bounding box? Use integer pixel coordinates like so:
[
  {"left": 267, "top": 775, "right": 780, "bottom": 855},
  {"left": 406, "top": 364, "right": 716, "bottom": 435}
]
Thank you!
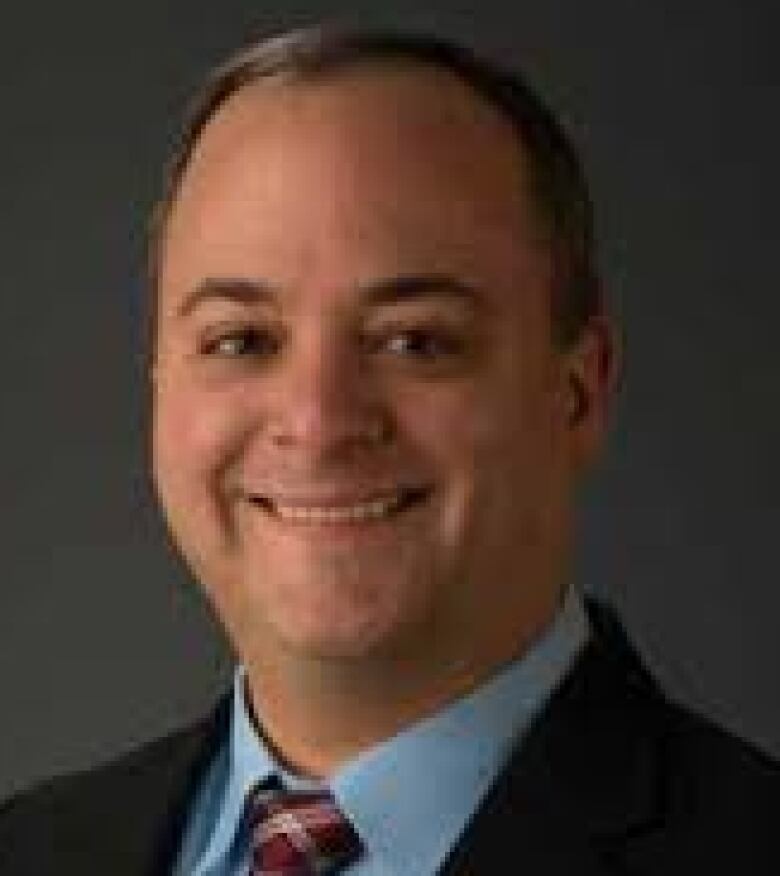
[{"left": 175, "top": 588, "right": 588, "bottom": 876}]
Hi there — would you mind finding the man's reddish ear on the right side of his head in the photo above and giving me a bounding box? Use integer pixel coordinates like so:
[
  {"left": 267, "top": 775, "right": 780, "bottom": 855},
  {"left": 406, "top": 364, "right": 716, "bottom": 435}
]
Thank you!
[{"left": 565, "top": 316, "right": 622, "bottom": 469}]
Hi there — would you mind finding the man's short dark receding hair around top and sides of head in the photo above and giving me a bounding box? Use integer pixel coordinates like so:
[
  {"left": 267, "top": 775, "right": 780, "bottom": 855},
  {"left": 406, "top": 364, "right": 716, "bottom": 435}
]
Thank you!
[{"left": 149, "top": 26, "right": 602, "bottom": 345}]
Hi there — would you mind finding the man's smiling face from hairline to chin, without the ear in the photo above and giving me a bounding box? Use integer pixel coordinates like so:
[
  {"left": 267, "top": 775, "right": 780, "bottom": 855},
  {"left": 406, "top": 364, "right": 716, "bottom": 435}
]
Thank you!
[{"left": 153, "top": 72, "right": 604, "bottom": 657}]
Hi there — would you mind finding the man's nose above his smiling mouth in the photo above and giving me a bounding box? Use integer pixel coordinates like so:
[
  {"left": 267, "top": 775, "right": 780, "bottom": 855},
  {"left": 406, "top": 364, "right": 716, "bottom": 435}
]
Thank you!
[{"left": 266, "top": 341, "right": 392, "bottom": 461}]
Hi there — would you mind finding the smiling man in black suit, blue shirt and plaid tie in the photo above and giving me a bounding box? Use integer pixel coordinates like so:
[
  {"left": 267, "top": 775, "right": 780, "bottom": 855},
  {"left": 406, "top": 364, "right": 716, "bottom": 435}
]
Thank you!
[{"left": 0, "top": 24, "right": 780, "bottom": 876}]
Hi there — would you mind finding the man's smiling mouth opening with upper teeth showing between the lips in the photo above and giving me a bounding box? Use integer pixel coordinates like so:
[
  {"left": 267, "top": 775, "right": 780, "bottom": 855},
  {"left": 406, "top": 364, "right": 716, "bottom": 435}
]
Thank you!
[{"left": 249, "top": 487, "right": 431, "bottom": 526}]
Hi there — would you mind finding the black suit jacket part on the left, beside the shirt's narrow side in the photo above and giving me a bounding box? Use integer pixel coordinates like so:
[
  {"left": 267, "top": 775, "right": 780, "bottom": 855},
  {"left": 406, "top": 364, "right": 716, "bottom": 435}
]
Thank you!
[{"left": 0, "top": 701, "right": 228, "bottom": 876}]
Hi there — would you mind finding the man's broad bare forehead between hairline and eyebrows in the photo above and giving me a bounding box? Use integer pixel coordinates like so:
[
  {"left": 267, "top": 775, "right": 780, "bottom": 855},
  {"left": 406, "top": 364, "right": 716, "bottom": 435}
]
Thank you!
[{"left": 163, "top": 67, "right": 534, "bottom": 302}]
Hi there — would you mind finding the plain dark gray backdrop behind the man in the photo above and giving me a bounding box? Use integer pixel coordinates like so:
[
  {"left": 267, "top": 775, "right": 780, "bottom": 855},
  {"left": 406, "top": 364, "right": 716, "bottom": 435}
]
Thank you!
[{"left": 0, "top": 0, "right": 780, "bottom": 797}]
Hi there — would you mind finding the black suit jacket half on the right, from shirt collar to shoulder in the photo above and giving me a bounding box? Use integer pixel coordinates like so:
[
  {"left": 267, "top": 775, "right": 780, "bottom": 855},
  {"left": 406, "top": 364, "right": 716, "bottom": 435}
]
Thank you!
[{"left": 445, "top": 603, "right": 780, "bottom": 876}]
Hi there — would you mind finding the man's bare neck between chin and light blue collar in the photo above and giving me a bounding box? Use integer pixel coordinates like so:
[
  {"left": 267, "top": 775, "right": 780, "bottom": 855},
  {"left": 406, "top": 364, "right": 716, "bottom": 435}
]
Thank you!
[{"left": 242, "top": 593, "right": 559, "bottom": 778}]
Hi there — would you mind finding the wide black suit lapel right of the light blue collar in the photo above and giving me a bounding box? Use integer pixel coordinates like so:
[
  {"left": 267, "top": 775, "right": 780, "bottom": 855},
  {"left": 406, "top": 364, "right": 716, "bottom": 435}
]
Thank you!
[{"left": 442, "top": 603, "right": 666, "bottom": 876}]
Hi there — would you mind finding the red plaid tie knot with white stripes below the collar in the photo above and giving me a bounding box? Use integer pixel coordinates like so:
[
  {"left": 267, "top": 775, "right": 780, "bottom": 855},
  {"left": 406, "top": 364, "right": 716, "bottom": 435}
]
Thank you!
[{"left": 249, "top": 788, "right": 361, "bottom": 876}]
